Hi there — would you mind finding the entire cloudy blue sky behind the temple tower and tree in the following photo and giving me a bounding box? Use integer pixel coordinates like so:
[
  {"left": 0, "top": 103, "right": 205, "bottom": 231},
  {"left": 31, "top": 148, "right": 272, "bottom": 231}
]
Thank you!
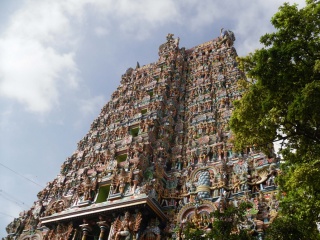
[{"left": 0, "top": 0, "right": 304, "bottom": 237}]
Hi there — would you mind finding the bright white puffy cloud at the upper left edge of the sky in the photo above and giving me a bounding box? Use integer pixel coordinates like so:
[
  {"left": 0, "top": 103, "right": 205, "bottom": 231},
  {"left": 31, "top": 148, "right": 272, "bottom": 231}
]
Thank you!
[{"left": 0, "top": 1, "right": 77, "bottom": 112}]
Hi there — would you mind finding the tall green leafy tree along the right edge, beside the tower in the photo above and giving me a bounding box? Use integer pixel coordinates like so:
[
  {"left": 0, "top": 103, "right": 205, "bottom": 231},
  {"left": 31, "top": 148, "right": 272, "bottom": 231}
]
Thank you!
[{"left": 230, "top": 0, "right": 320, "bottom": 239}]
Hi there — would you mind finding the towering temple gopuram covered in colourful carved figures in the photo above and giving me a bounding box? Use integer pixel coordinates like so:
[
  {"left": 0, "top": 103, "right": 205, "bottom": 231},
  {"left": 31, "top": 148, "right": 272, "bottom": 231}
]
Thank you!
[{"left": 5, "top": 31, "right": 279, "bottom": 240}]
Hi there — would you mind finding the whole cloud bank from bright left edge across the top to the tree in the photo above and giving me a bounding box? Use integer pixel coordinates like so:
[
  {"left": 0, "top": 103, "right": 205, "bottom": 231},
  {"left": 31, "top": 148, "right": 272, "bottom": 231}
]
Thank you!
[{"left": 0, "top": 0, "right": 303, "bottom": 113}]
